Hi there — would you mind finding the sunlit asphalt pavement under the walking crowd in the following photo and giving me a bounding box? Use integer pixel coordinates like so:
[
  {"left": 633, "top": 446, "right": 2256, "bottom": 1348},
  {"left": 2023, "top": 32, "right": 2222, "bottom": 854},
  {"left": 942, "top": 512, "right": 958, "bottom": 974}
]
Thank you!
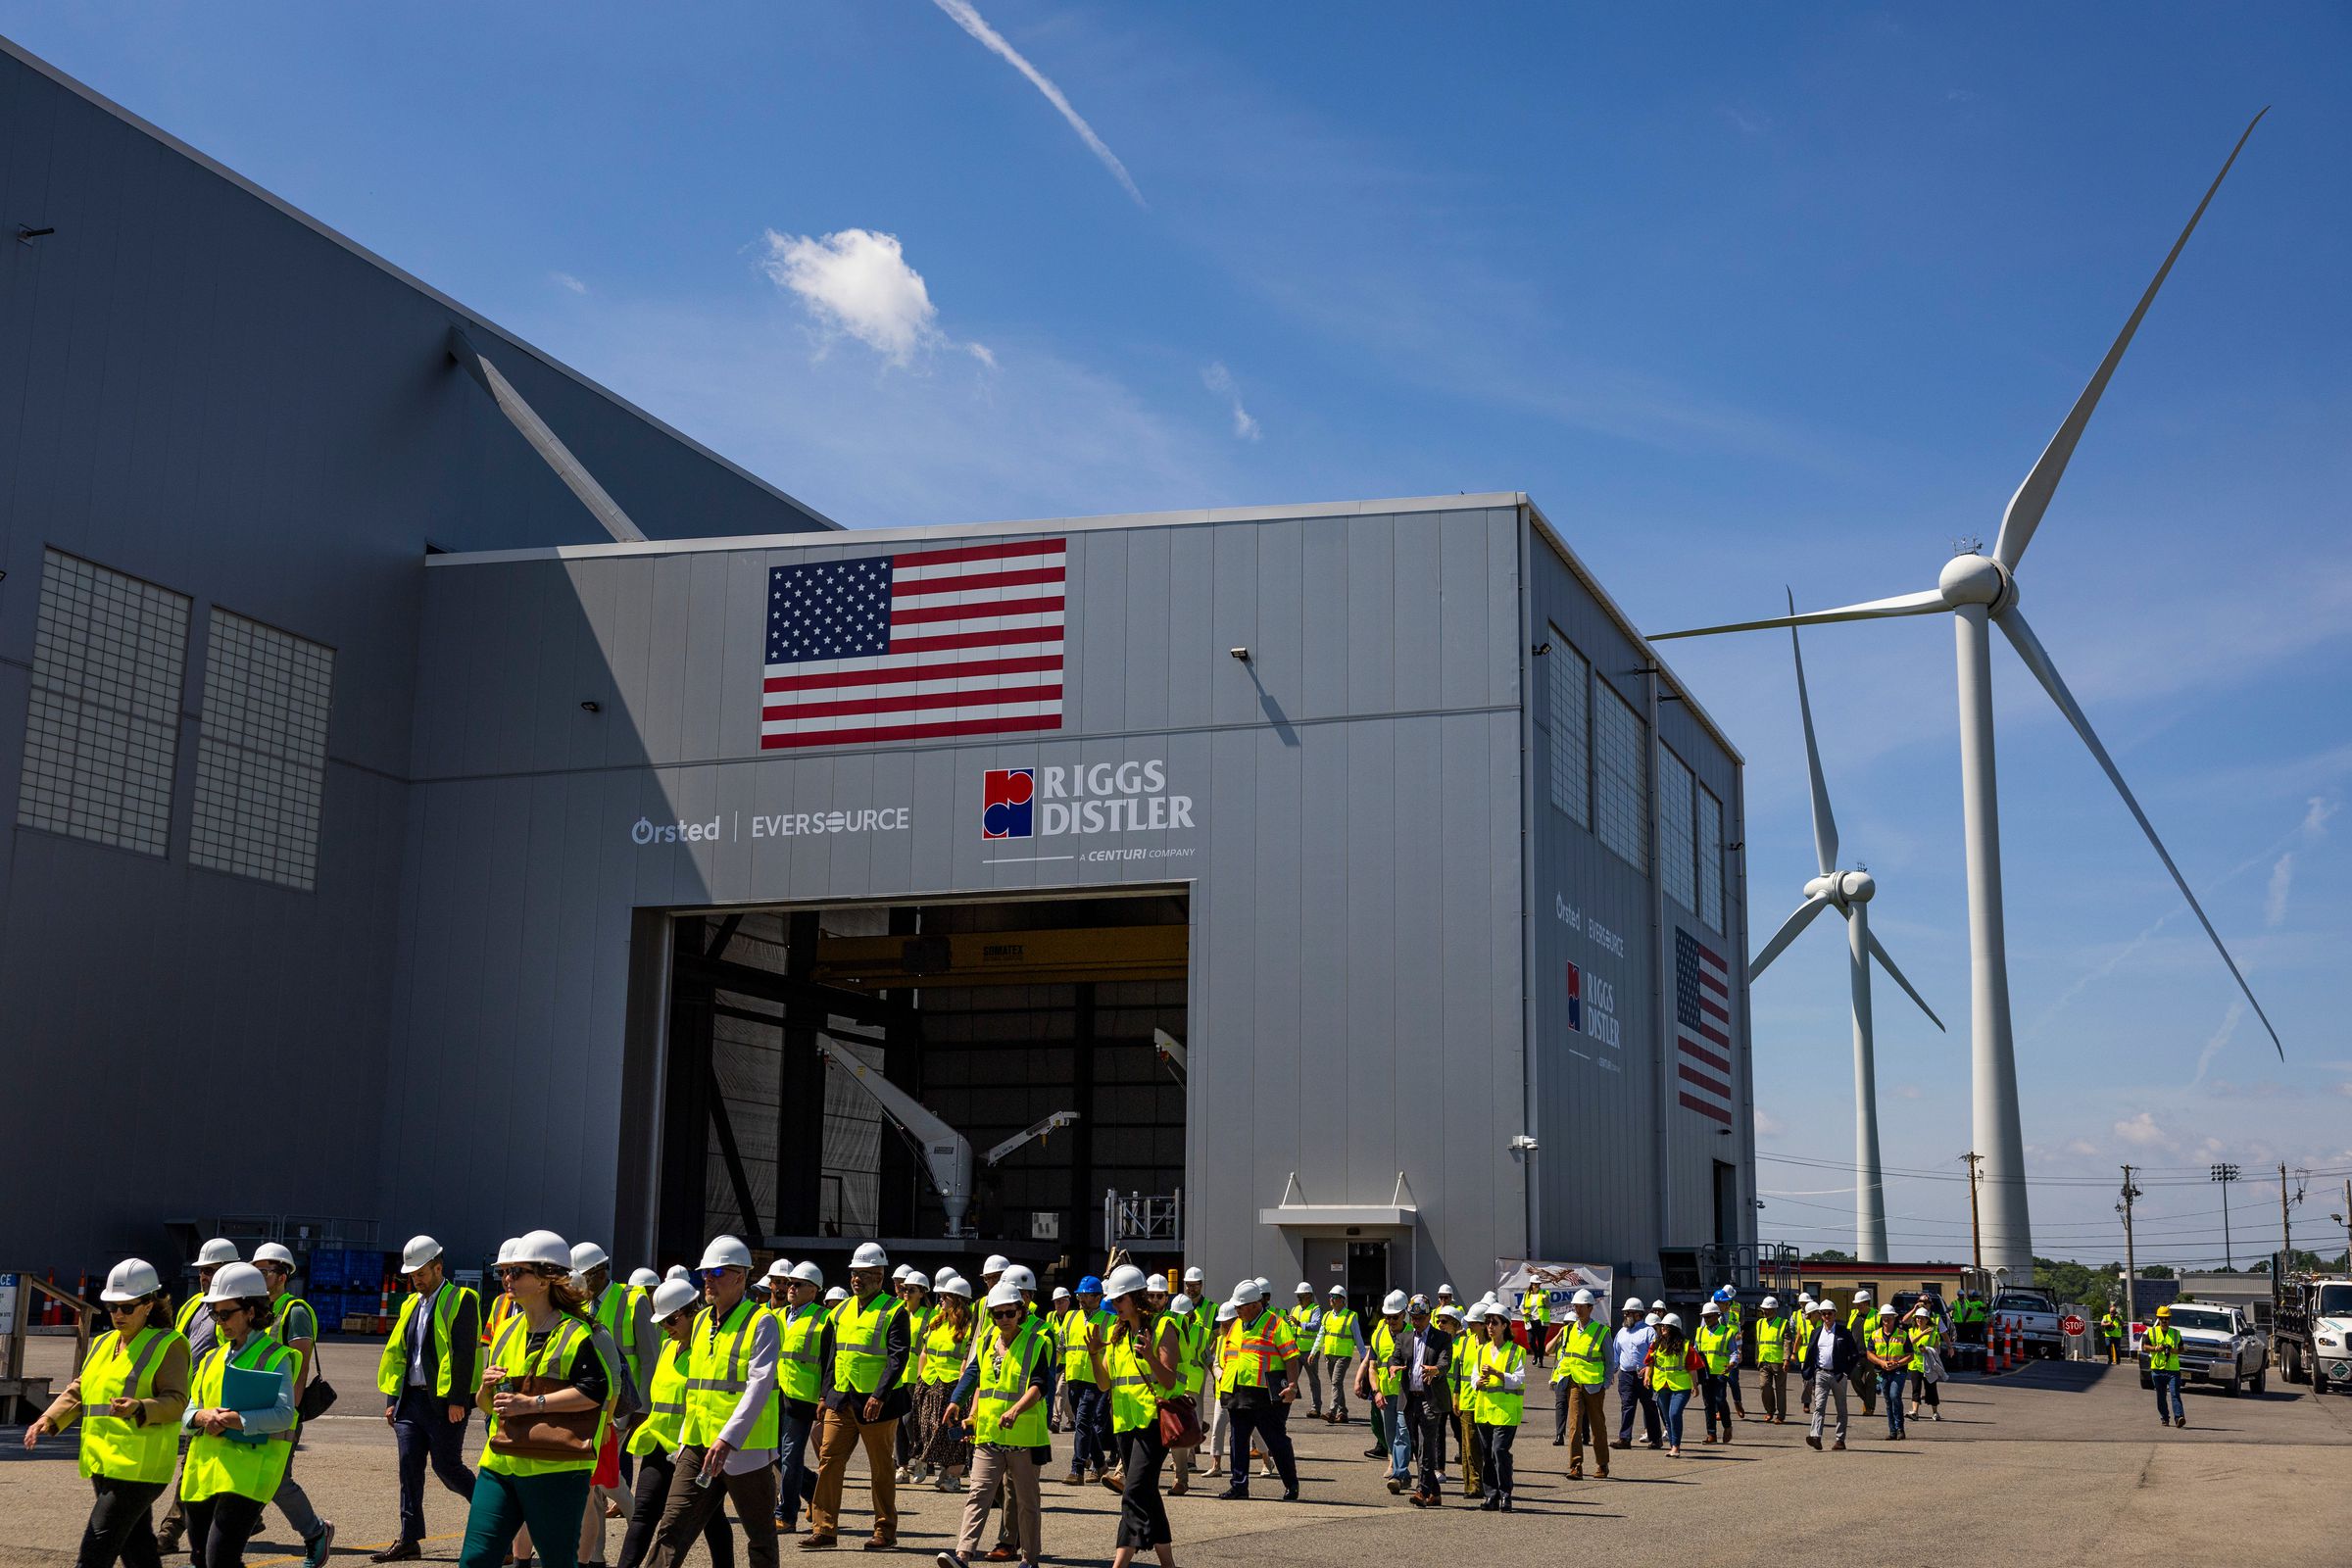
[{"left": 0, "top": 1340, "right": 2352, "bottom": 1568}]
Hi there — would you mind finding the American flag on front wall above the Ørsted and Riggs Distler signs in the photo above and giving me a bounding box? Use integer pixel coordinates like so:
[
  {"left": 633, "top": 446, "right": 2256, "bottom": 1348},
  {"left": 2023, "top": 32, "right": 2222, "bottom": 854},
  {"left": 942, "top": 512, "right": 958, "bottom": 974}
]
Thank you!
[{"left": 760, "top": 538, "right": 1068, "bottom": 750}]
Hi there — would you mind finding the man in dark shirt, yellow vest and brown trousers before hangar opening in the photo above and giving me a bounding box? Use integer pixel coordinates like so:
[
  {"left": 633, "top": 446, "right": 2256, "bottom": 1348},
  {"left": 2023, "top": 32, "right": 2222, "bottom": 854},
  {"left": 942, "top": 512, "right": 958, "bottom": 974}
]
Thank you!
[{"left": 808, "top": 1242, "right": 915, "bottom": 1568}]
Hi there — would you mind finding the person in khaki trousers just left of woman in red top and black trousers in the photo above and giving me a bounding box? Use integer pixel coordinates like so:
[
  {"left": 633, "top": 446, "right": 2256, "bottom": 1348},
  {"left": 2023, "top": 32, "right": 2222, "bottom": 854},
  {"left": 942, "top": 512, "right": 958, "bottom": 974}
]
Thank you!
[{"left": 941, "top": 1269, "right": 1049, "bottom": 1563}]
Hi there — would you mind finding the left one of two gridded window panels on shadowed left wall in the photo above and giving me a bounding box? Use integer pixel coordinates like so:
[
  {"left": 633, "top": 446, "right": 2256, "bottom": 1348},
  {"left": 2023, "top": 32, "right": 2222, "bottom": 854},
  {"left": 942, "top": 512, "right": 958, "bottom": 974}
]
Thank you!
[{"left": 17, "top": 550, "right": 190, "bottom": 856}]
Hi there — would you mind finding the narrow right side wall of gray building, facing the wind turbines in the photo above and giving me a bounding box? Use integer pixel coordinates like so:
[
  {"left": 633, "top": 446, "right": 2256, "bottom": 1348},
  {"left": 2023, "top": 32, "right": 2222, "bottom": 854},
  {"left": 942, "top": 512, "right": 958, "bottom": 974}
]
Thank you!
[{"left": 1529, "top": 516, "right": 1754, "bottom": 1281}]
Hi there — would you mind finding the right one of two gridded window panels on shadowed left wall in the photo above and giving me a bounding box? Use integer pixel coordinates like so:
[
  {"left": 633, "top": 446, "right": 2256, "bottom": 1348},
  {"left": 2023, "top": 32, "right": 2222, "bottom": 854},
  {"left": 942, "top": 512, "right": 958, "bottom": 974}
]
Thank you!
[{"left": 188, "top": 609, "right": 334, "bottom": 891}]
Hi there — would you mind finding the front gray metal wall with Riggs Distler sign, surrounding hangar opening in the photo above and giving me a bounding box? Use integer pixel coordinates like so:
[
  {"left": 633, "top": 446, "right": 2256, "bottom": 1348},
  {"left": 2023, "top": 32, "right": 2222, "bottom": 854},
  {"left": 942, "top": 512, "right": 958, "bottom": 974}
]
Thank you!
[{"left": 400, "top": 496, "right": 1524, "bottom": 1289}]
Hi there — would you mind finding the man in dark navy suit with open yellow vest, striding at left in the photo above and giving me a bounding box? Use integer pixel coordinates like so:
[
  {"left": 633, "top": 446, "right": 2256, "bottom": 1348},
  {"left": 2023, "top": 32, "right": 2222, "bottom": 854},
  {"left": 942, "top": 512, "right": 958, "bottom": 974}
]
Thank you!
[{"left": 369, "top": 1237, "right": 479, "bottom": 1563}]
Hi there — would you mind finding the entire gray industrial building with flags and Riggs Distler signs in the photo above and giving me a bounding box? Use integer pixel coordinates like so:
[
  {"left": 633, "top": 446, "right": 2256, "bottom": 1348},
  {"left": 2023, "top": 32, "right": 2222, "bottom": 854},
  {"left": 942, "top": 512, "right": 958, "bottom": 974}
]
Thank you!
[{"left": 0, "top": 36, "right": 1754, "bottom": 1298}]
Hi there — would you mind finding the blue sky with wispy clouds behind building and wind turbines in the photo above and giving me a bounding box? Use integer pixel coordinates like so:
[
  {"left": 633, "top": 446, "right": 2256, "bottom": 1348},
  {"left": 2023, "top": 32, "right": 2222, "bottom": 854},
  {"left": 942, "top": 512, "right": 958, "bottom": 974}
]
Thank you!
[{"left": 0, "top": 0, "right": 2352, "bottom": 1260}]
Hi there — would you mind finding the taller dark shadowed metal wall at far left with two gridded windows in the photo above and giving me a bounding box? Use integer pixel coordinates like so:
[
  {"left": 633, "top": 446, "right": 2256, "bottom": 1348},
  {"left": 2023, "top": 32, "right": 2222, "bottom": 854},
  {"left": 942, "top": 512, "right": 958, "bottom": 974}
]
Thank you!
[{"left": 0, "top": 42, "right": 823, "bottom": 1267}]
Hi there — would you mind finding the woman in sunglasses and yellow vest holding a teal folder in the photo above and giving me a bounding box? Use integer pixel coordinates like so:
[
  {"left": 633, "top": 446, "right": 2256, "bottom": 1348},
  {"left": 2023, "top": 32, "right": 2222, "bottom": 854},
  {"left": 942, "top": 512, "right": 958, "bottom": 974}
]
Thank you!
[{"left": 178, "top": 1262, "right": 296, "bottom": 1568}]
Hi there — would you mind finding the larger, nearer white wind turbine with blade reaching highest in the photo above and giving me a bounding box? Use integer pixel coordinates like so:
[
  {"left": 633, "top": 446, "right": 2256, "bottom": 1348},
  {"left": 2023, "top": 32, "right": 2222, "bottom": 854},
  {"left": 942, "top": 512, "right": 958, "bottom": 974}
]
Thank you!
[{"left": 1651, "top": 108, "right": 2286, "bottom": 1279}]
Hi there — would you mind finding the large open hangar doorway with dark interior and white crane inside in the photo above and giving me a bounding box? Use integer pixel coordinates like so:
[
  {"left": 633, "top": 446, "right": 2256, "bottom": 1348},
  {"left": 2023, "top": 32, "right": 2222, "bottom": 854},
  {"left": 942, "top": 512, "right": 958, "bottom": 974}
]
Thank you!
[{"left": 654, "top": 889, "right": 1190, "bottom": 1269}]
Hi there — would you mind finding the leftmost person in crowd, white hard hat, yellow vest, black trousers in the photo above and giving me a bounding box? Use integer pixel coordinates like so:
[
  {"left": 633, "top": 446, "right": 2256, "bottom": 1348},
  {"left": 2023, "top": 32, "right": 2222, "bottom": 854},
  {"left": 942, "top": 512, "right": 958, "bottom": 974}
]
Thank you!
[{"left": 24, "top": 1257, "right": 188, "bottom": 1568}]
